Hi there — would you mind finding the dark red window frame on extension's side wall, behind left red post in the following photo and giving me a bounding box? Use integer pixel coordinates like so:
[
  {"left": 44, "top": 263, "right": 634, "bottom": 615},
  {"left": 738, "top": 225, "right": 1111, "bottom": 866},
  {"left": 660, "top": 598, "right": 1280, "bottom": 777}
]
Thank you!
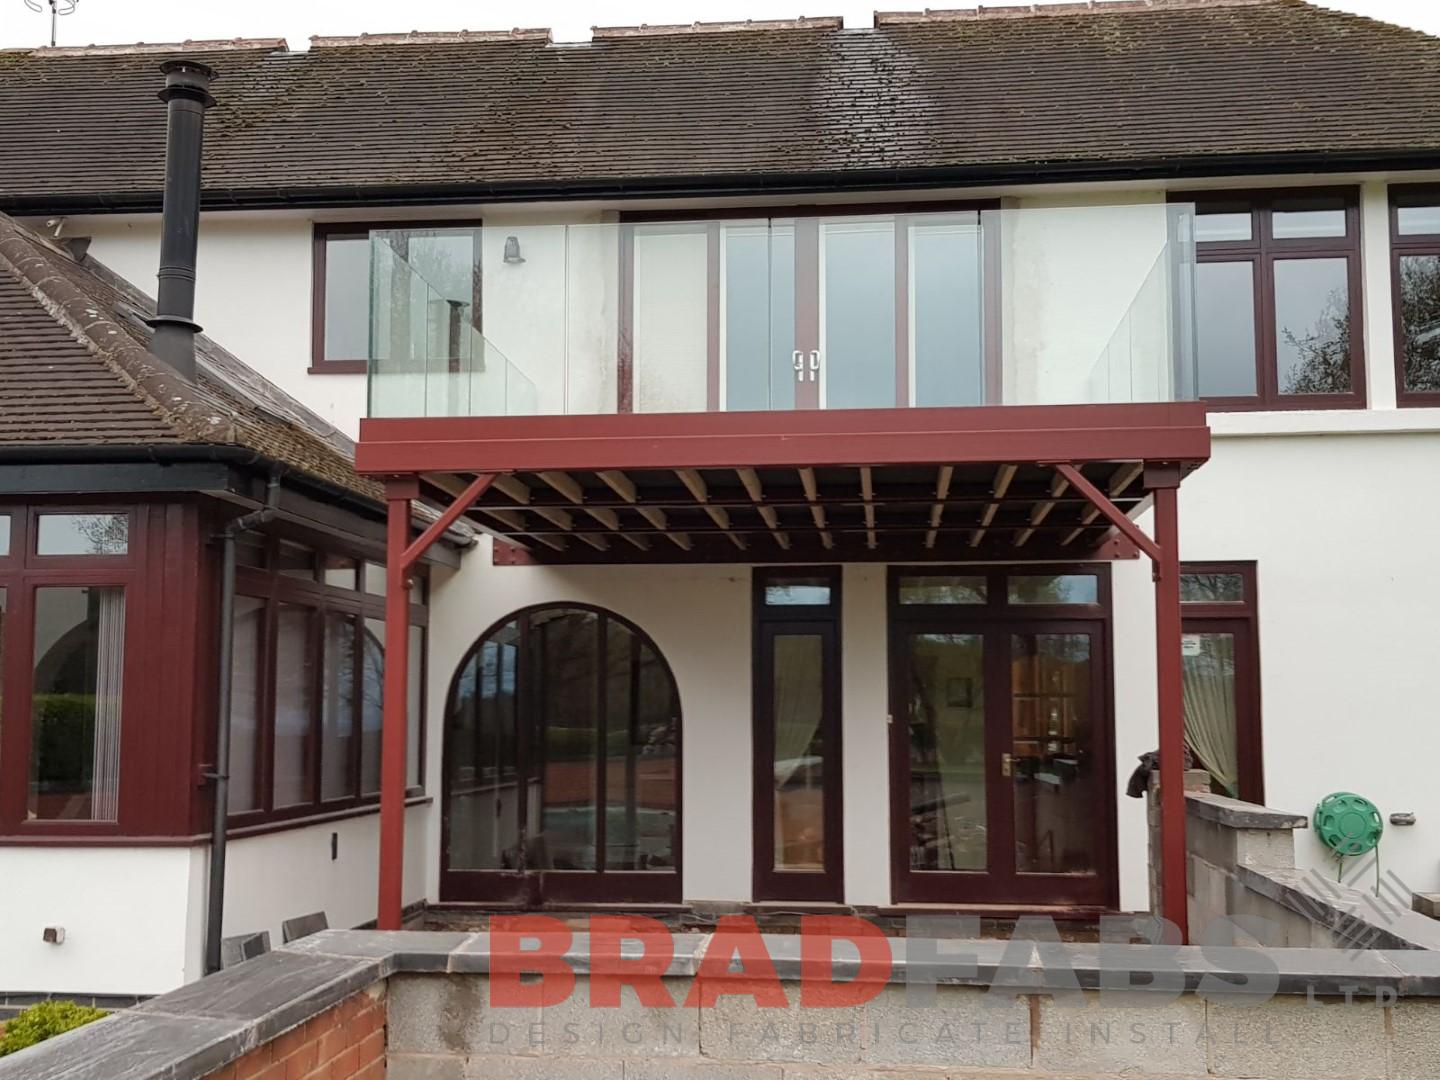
[{"left": 230, "top": 536, "right": 429, "bottom": 829}]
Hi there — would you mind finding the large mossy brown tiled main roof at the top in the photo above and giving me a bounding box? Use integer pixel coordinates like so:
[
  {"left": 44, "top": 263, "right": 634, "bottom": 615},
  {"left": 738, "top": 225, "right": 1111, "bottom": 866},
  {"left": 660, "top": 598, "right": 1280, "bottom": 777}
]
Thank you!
[{"left": 0, "top": 0, "right": 1440, "bottom": 210}]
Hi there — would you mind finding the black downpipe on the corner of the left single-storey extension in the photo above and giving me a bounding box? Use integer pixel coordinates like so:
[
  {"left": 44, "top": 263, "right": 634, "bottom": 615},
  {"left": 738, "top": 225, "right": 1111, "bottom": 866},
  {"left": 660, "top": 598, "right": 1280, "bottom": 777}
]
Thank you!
[{"left": 204, "top": 469, "right": 281, "bottom": 975}]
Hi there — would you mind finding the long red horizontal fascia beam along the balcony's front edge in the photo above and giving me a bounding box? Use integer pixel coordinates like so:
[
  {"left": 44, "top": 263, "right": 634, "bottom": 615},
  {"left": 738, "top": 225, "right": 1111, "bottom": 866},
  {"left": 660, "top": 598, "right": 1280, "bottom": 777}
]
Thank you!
[{"left": 356, "top": 402, "right": 1210, "bottom": 474}]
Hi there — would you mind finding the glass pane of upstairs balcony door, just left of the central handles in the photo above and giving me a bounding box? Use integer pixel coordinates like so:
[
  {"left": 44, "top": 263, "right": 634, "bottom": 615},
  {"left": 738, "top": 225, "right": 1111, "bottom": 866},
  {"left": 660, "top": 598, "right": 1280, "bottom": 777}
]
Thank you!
[{"left": 723, "top": 222, "right": 795, "bottom": 412}]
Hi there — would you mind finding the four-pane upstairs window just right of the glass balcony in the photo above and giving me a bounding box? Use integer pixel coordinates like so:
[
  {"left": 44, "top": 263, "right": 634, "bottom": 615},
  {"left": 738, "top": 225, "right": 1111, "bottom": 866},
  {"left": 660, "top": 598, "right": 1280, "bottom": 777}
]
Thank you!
[{"left": 1176, "top": 189, "right": 1365, "bottom": 409}]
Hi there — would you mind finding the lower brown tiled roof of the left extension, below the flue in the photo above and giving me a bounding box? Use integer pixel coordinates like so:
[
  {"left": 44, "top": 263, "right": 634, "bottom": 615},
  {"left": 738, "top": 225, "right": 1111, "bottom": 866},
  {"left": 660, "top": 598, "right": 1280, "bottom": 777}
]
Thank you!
[{"left": 0, "top": 213, "right": 383, "bottom": 501}]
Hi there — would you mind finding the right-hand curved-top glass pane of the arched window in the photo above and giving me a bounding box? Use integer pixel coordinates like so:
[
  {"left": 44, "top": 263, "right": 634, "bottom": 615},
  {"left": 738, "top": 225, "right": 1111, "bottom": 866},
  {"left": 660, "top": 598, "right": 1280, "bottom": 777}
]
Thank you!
[{"left": 605, "top": 619, "right": 680, "bottom": 871}]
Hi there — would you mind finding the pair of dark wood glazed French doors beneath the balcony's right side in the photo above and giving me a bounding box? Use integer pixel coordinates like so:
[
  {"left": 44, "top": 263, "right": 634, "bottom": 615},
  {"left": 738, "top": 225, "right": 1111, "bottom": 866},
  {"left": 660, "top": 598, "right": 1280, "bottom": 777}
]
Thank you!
[{"left": 890, "top": 616, "right": 1115, "bottom": 906}]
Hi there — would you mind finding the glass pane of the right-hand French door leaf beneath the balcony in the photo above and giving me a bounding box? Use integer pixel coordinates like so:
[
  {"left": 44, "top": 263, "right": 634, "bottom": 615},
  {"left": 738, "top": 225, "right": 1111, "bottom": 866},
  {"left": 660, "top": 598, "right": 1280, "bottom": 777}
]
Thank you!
[{"left": 1009, "top": 634, "right": 1103, "bottom": 874}]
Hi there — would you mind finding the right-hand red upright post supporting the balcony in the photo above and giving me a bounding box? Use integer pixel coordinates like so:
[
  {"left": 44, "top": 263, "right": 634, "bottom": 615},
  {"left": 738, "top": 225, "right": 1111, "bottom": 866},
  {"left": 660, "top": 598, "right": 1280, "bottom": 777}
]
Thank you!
[{"left": 1146, "top": 475, "right": 1189, "bottom": 942}]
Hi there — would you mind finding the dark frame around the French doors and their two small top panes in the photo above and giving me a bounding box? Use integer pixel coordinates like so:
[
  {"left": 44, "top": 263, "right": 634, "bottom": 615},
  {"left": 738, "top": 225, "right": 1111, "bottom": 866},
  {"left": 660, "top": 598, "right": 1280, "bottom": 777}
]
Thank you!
[{"left": 886, "top": 563, "right": 1120, "bottom": 912}]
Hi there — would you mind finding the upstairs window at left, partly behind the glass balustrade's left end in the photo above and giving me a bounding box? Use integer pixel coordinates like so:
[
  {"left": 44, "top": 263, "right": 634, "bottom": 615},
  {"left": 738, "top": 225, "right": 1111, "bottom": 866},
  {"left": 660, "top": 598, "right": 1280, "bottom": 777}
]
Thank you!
[{"left": 310, "top": 222, "right": 481, "bottom": 374}]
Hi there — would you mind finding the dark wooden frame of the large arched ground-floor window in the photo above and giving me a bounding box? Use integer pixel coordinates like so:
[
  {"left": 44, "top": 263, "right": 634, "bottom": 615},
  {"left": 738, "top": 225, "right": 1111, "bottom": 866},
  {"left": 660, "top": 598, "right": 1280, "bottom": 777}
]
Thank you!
[{"left": 441, "top": 600, "right": 684, "bottom": 909}]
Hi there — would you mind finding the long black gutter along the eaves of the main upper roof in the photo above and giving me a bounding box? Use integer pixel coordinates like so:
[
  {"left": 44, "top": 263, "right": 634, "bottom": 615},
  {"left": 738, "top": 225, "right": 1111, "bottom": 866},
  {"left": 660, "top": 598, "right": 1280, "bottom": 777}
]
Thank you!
[{"left": 8, "top": 147, "right": 1440, "bottom": 216}]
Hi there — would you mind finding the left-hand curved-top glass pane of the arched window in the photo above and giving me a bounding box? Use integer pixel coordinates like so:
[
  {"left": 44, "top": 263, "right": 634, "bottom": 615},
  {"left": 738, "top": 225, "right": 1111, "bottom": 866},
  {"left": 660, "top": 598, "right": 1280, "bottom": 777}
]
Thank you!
[{"left": 445, "top": 622, "right": 520, "bottom": 870}]
